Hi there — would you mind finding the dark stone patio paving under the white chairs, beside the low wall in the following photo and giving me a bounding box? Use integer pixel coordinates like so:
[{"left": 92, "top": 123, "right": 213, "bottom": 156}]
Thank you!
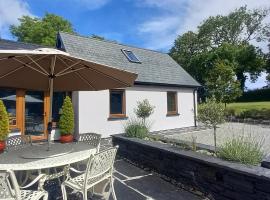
[{"left": 43, "top": 159, "right": 203, "bottom": 200}]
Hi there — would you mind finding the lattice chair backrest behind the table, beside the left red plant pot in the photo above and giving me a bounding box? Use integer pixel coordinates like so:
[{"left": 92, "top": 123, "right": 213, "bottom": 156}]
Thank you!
[{"left": 6, "top": 135, "right": 32, "bottom": 149}]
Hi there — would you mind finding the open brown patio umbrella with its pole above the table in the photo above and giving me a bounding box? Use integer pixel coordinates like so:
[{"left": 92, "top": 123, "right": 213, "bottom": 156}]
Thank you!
[{"left": 0, "top": 48, "right": 137, "bottom": 143}]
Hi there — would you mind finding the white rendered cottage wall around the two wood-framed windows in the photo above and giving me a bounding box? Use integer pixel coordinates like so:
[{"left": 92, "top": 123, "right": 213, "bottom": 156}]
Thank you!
[{"left": 73, "top": 86, "right": 197, "bottom": 137}]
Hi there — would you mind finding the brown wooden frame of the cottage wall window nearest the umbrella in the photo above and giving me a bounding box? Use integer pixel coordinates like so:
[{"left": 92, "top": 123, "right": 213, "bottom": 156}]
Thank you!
[{"left": 108, "top": 89, "right": 127, "bottom": 119}]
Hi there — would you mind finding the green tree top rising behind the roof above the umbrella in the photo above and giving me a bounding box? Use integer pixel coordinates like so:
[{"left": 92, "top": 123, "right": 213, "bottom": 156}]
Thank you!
[{"left": 10, "top": 13, "right": 74, "bottom": 47}]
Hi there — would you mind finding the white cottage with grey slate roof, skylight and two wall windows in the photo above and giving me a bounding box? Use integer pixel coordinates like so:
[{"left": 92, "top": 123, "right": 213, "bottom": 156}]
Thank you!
[{"left": 57, "top": 32, "right": 200, "bottom": 137}]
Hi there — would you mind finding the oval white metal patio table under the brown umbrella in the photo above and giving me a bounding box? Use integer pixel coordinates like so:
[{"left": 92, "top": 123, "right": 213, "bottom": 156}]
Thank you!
[{"left": 0, "top": 142, "right": 96, "bottom": 187}]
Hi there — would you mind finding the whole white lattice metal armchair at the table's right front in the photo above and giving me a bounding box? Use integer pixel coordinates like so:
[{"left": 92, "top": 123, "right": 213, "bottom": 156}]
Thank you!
[{"left": 61, "top": 147, "right": 118, "bottom": 200}]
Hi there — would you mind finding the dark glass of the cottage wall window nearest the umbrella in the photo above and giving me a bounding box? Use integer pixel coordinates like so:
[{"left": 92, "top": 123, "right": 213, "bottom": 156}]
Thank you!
[{"left": 110, "top": 91, "right": 123, "bottom": 114}]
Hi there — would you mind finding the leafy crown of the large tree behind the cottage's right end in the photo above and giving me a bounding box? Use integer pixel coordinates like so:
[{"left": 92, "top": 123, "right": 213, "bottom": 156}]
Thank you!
[{"left": 170, "top": 7, "right": 270, "bottom": 91}]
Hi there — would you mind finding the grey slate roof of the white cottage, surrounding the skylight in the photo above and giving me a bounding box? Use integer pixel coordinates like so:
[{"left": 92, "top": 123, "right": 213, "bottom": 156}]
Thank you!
[{"left": 58, "top": 32, "right": 200, "bottom": 87}]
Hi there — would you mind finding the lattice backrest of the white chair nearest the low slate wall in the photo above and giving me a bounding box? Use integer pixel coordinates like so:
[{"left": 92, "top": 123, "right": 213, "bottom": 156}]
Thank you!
[{"left": 85, "top": 146, "right": 118, "bottom": 187}]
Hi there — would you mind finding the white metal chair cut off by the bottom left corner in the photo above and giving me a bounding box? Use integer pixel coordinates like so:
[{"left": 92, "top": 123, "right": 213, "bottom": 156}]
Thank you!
[{"left": 0, "top": 170, "right": 48, "bottom": 200}]
